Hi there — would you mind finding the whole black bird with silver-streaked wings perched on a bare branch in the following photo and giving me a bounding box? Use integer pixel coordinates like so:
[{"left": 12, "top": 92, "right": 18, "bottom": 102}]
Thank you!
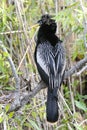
[{"left": 34, "top": 14, "right": 65, "bottom": 123}]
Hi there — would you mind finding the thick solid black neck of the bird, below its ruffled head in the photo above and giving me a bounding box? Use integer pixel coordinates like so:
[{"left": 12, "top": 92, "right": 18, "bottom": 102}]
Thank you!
[{"left": 38, "top": 26, "right": 60, "bottom": 46}]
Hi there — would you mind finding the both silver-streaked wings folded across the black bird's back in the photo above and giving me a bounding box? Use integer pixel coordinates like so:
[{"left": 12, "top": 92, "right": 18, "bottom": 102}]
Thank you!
[{"left": 36, "top": 41, "right": 65, "bottom": 89}]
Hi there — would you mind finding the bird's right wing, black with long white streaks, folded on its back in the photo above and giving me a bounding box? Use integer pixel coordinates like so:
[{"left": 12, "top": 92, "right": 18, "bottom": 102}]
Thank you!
[{"left": 49, "top": 43, "right": 66, "bottom": 90}]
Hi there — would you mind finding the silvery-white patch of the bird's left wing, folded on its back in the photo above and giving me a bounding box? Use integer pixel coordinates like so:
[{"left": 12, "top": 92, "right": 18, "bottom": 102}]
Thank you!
[{"left": 36, "top": 41, "right": 52, "bottom": 77}]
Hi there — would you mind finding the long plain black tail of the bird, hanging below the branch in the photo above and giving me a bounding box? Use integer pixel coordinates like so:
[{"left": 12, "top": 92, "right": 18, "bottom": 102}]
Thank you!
[{"left": 46, "top": 88, "right": 59, "bottom": 123}]
